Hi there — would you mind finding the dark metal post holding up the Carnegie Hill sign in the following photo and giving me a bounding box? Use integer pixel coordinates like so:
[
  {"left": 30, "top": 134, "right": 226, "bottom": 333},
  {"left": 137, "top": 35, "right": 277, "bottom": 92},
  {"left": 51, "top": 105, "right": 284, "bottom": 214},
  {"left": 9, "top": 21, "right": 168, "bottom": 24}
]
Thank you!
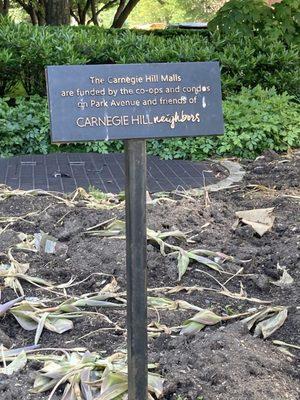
[{"left": 125, "top": 139, "right": 148, "bottom": 400}]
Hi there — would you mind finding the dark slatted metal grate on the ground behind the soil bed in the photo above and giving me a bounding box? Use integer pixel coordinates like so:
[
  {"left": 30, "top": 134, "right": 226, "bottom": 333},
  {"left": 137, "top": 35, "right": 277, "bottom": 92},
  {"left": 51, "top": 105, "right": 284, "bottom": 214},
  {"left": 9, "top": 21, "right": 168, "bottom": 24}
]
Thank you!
[{"left": 0, "top": 153, "right": 227, "bottom": 193}]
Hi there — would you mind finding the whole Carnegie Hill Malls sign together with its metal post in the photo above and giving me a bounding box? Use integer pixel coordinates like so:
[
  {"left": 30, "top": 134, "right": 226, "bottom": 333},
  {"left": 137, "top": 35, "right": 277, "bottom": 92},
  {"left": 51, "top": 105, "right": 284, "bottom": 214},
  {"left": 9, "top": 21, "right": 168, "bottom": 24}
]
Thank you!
[{"left": 46, "top": 62, "right": 224, "bottom": 400}]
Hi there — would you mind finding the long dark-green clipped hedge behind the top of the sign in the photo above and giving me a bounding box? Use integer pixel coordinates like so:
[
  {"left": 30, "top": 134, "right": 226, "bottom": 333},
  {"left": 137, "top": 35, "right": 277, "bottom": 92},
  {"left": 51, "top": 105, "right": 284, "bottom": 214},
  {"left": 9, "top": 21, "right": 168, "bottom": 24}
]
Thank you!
[{"left": 0, "top": 17, "right": 300, "bottom": 99}]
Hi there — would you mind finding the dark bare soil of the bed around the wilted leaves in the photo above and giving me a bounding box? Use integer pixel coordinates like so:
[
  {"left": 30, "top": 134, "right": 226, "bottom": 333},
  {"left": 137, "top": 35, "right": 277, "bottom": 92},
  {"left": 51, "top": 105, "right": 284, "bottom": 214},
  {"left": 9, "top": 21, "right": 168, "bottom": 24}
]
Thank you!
[{"left": 0, "top": 152, "right": 300, "bottom": 400}]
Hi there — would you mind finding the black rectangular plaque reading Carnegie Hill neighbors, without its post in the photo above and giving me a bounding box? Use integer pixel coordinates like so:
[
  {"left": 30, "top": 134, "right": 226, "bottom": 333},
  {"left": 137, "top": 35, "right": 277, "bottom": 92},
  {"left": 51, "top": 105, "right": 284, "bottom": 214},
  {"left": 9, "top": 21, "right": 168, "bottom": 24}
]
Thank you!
[{"left": 46, "top": 62, "right": 224, "bottom": 143}]
